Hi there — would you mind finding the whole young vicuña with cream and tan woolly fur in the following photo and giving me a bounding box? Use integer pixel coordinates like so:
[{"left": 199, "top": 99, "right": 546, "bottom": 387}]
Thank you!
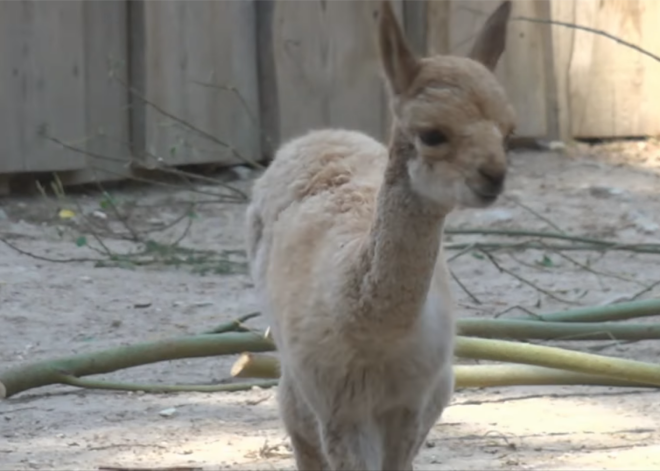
[{"left": 247, "top": 1, "right": 514, "bottom": 470}]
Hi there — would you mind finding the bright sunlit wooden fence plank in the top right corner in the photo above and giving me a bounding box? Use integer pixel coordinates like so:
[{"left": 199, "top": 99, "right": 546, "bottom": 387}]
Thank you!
[{"left": 569, "top": 0, "right": 660, "bottom": 138}]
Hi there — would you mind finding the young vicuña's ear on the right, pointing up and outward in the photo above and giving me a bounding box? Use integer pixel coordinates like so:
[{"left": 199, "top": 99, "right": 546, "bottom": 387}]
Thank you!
[{"left": 468, "top": 0, "right": 511, "bottom": 71}]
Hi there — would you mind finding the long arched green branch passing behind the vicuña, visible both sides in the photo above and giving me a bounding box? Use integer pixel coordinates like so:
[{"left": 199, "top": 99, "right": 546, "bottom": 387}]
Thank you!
[{"left": 0, "top": 333, "right": 660, "bottom": 398}]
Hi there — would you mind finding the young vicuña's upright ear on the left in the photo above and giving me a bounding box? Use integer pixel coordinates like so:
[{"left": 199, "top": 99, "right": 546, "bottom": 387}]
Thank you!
[{"left": 378, "top": 0, "right": 419, "bottom": 95}]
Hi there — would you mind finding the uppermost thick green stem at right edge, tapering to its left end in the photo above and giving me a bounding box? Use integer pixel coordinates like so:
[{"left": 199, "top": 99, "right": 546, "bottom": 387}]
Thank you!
[{"left": 528, "top": 299, "right": 660, "bottom": 322}]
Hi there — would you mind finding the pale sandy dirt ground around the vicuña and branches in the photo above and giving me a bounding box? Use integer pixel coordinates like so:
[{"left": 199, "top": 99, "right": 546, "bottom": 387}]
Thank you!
[{"left": 0, "top": 142, "right": 660, "bottom": 471}]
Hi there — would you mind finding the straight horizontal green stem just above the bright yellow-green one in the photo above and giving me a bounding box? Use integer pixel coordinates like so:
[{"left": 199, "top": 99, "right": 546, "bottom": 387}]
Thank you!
[{"left": 458, "top": 318, "right": 660, "bottom": 340}]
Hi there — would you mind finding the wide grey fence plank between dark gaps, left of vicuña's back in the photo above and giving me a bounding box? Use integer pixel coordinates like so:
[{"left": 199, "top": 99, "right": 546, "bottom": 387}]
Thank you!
[{"left": 132, "top": 0, "right": 260, "bottom": 168}]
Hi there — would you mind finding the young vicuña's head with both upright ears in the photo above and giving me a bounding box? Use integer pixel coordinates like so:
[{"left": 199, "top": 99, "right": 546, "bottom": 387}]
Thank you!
[{"left": 378, "top": 0, "right": 515, "bottom": 209}]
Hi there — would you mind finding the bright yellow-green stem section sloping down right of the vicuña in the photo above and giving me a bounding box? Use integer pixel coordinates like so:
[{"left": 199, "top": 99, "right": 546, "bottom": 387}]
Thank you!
[{"left": 455, "top": 336, "right": 660, "bottom": 386}]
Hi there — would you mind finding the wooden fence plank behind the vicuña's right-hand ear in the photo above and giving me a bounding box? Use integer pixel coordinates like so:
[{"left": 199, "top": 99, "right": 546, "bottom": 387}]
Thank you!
[{"left": 438, "top": 0, "right": 554, "bottom": 138}]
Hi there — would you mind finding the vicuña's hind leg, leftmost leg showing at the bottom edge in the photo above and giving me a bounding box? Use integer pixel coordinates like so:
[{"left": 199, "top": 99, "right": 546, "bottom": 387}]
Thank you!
[{"left": 277, "top": 371, "right": 329, "bottom": 471}]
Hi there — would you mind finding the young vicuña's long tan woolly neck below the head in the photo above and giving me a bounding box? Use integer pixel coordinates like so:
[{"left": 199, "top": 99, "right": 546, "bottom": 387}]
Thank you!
[{"left": 358, "top": 129, "right": 446, "bottom": 334}]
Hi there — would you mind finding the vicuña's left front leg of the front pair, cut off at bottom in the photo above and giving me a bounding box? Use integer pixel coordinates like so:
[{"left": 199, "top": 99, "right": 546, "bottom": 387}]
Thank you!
[{"left": 322, "top": 416, "right": 383, "bottom": 471}]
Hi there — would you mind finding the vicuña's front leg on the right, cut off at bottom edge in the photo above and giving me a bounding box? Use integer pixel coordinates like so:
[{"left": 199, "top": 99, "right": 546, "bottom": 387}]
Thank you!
[{"left": 379, "top": 407, "right": 422, "bottom": 471}]
